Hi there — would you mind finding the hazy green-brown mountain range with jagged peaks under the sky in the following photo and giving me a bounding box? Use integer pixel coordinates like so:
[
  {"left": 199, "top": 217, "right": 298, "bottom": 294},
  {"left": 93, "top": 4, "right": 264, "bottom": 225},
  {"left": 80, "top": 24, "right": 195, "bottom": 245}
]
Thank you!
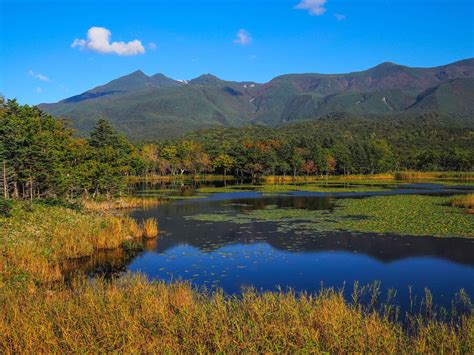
[{"left": 40, "top": 58, "right": 474, "bottom": 140}]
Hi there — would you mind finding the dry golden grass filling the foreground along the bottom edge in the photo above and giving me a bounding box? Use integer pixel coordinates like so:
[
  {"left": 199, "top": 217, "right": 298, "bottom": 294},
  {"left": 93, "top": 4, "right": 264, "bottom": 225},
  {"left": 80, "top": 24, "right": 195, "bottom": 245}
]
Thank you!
[{"left": 0, "top": 277, "right": 474, "bottom": 354}]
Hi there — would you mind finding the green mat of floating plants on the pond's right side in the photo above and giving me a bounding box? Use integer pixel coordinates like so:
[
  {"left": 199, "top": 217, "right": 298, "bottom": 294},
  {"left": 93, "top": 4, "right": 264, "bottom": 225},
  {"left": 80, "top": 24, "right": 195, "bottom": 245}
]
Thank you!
[{"left": 187, "top": 195, "right": 474, "bottom": 237}]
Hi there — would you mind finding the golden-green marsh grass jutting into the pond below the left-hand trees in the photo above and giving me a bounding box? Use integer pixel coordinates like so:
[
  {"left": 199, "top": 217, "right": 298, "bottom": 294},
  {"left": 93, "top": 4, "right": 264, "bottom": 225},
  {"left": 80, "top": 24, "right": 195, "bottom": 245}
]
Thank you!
[{"left": 0, "top": 202, "right": 159, "bottom": 285}]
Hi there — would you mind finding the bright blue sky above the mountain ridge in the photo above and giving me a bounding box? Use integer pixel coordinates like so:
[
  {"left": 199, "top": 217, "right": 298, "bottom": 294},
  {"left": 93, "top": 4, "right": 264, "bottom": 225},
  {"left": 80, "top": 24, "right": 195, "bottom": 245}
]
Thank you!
[{"left": 0, "top": 0, "right": 474, "bottom": 104}]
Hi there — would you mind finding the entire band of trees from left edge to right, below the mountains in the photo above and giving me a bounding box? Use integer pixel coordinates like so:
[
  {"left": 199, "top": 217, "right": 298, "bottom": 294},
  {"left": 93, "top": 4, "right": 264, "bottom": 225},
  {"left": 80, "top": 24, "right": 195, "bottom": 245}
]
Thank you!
[{"left": 0, "top": 98, "right": 474, "bottom": 199}]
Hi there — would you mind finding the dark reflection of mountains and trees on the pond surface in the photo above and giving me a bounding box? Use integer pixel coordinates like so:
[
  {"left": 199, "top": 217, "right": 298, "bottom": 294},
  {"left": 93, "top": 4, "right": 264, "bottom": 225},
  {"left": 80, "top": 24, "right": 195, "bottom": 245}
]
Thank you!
[{"left": 132, "top": 193, "right": 474, "bottom": 265}]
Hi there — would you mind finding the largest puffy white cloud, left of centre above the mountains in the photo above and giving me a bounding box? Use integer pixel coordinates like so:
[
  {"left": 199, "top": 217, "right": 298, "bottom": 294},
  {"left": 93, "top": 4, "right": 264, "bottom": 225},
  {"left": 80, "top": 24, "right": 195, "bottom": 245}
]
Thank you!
[{"left": 71, "top": 27, "right": 145, "bottom": 56}]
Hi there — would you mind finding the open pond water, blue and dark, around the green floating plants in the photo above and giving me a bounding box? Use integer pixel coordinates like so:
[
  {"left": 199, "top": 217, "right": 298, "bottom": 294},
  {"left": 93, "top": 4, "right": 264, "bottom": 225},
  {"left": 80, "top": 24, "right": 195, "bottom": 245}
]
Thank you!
[{"left": 90, "top": 184, "right": 474, "bottom": 308}]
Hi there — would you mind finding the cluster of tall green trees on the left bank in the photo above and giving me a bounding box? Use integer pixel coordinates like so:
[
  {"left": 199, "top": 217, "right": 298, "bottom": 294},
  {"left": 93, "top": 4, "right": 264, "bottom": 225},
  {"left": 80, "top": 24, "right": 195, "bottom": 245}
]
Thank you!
[{"left": 0, "top": 100, "right": 143, "bottom": 200}]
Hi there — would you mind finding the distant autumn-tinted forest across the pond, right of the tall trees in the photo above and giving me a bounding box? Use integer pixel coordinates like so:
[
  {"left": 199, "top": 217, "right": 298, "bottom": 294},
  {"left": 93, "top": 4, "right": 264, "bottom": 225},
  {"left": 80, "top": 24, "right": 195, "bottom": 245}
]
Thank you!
[{"left": 141, "top": 114, "right": 474, "bottom": 178}]
